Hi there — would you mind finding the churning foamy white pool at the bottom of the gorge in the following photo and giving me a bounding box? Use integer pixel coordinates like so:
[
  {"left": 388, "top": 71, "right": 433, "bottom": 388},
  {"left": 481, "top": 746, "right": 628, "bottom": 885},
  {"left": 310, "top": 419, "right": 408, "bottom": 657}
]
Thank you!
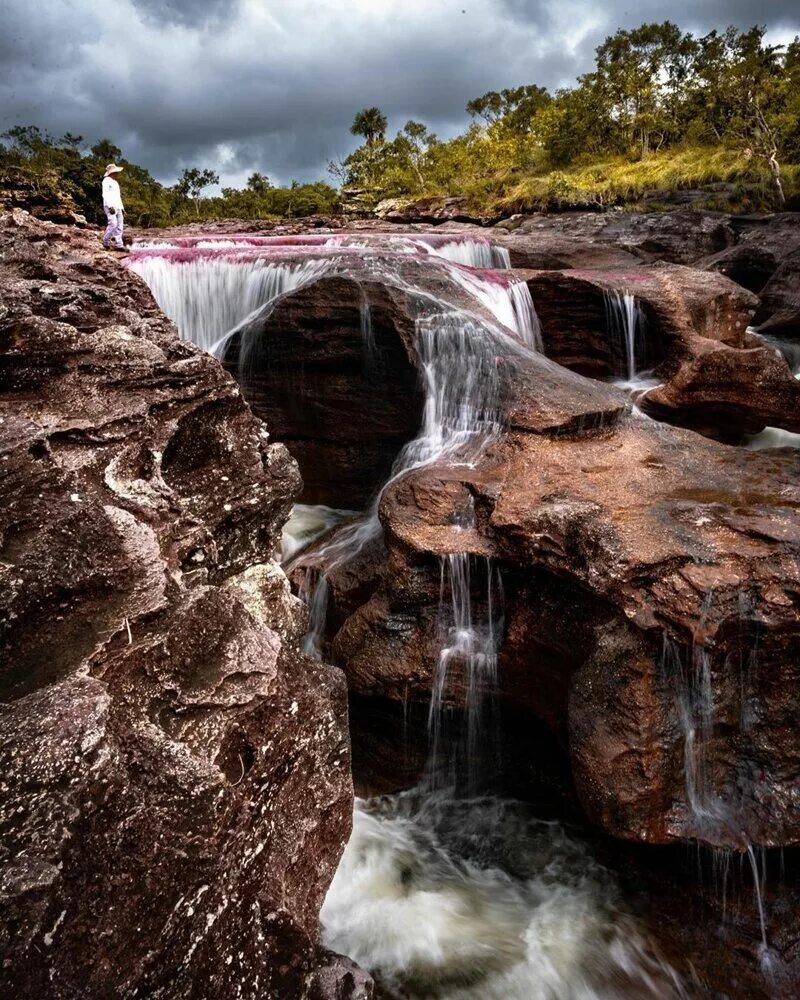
[{"left": 321, "top": 792, "right": 685, "bottom": 1000}]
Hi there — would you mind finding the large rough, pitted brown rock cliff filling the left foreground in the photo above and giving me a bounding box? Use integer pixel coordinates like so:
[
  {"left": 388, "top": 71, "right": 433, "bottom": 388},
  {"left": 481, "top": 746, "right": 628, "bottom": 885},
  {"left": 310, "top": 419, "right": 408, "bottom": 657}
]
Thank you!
[{"left": 0, "top": 212, "right": 370, "bottom": 1000}]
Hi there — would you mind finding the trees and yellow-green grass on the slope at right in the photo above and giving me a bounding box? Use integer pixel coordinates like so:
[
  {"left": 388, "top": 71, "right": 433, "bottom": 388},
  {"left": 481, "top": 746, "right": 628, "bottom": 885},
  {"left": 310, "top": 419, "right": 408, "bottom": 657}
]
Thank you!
[{"left": 331, "top": 21, "right": 800, "bottom": 213}]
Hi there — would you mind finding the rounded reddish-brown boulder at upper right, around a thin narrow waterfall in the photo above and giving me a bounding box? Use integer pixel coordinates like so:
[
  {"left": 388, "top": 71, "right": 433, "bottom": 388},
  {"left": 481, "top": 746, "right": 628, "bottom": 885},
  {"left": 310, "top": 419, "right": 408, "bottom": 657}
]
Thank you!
[{"left": 522, "top": 264, "right": 800, "bottom": 443}]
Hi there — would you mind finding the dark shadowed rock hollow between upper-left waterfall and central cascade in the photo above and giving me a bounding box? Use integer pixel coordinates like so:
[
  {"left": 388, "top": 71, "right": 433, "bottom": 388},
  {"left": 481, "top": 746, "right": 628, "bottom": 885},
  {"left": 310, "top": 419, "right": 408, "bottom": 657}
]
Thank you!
[{"left": 219, "top": 277, "right": 422, "bottom": 509}]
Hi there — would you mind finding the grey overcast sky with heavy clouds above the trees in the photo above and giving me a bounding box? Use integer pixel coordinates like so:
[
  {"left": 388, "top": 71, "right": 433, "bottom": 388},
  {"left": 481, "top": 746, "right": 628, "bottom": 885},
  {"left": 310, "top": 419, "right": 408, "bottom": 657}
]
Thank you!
[{"left": 0, "top": 0, "right": 800, "bottom": 185}]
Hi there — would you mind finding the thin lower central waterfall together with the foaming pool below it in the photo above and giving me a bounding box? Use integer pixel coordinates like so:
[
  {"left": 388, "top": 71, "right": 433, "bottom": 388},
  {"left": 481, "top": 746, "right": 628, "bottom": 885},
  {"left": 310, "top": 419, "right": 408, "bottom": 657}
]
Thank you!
[{"left": 321, "top": 554, "right": 685, "bottom": 1000}]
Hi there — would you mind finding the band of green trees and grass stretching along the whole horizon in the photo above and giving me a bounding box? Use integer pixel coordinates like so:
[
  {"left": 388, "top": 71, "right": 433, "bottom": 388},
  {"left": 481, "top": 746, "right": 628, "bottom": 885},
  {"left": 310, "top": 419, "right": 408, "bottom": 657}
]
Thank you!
[{"left": 0, "top": 21, "right": 800, "bottom": 226}]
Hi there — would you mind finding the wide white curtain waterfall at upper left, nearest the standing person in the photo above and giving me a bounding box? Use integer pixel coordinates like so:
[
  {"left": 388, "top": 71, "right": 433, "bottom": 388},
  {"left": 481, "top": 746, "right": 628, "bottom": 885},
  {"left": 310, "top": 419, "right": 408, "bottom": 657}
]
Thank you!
[{"left": 129, "top": 252, "right": 327, "bottom": 351}]
